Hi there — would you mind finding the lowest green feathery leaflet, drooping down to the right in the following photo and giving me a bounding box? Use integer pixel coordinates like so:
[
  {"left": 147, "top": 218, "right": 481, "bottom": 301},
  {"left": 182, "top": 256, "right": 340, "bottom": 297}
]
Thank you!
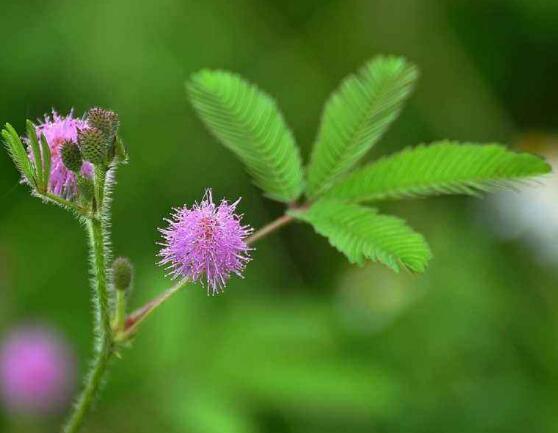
[{"left": 290, "top": 199, "right": 431, "bottom": 272}]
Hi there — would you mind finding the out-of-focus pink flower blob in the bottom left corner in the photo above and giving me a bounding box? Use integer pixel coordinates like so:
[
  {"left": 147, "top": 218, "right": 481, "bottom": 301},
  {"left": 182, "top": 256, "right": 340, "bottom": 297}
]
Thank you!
[{"left": 0, "top": 326, "right": 74, "bottom": 415}]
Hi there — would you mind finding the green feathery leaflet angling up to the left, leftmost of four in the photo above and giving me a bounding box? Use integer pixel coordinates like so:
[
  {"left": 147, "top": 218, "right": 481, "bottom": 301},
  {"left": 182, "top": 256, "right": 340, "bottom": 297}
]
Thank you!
[{"left": 187, "top": 70, "right": 303, "bottom": 202}]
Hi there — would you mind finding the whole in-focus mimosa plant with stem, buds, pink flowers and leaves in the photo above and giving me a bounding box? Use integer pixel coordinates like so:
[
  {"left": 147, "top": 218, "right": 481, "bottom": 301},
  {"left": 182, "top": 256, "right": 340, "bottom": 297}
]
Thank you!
[{"left": 2, "top": 57, "right": 550, "bottom": 433}]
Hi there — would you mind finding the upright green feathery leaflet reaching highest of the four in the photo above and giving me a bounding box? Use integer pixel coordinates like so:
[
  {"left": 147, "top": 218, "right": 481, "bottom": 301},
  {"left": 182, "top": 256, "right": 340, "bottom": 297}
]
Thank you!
[{"left": 308, "top": 57, "right": 418, "bottom": 197}]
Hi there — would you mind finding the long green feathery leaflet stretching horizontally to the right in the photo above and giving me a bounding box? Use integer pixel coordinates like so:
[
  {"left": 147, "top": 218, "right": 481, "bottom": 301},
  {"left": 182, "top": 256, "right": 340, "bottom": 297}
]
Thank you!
[{"left": 326, "top": 141, "right": 550, "bottom": 202}]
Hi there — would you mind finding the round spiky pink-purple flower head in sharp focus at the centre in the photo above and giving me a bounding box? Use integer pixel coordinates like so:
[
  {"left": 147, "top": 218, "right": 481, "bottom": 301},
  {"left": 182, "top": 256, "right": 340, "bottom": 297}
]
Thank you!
[{"left": 159, "top": 190, "right": 252, "bottom": 295}]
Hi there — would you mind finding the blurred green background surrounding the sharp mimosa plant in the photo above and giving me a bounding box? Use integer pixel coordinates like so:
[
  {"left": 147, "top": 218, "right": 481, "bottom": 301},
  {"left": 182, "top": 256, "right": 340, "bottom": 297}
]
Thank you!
[{"left": 0, "top": 0, "right": 558, "bottom": 433}]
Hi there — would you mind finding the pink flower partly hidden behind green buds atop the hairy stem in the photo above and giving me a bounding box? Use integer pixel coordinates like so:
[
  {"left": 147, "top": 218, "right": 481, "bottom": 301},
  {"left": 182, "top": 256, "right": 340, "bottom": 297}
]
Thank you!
[{"left": 31, "top": 111, "right": 93, "bottom": 199}]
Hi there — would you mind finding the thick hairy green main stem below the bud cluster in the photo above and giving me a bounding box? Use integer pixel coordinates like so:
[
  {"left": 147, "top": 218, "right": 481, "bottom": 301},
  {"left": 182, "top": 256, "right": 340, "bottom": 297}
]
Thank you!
[{"left": 63, "top": 172, "right": 114, "bottom": 433}]
